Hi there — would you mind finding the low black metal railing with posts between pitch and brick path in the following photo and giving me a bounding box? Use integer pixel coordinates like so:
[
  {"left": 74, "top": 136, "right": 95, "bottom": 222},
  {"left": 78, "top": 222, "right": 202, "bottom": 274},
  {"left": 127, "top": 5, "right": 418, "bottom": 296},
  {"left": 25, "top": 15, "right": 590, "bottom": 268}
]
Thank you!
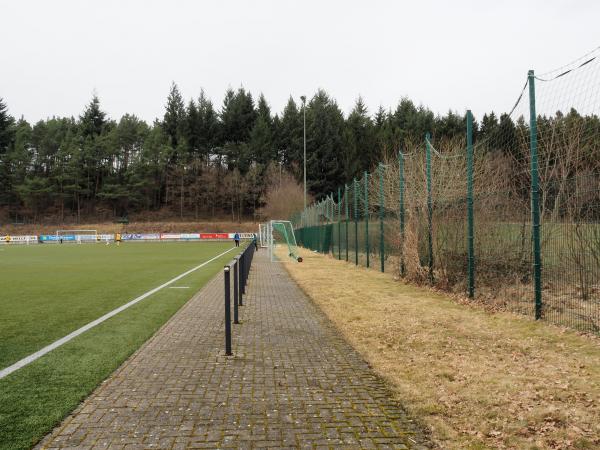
[{"left": 223, "top": 242, "right": 255, "bottom": 356}]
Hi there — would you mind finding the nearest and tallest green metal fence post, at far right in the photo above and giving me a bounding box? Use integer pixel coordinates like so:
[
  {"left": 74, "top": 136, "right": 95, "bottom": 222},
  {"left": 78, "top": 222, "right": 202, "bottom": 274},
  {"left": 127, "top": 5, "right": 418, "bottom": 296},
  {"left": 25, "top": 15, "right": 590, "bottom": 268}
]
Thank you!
[{"left": 527, "top": 70, "right": 542, "bottom": 320}]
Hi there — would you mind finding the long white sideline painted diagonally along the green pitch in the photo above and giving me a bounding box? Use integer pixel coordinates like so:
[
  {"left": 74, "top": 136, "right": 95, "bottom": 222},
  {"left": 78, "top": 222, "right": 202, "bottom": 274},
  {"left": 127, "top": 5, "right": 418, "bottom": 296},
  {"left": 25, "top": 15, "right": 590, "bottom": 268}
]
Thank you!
[{"left": 0, "top": 247, "right": 238, "bottom": 380}]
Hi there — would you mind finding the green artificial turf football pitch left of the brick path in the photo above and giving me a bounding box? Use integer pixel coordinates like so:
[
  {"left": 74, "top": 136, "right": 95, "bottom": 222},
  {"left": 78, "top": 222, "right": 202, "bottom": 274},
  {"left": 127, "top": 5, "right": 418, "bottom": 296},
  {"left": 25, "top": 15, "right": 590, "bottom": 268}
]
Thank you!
[{"left": 0, "top": 243, "right": 234, "bottom": 449}]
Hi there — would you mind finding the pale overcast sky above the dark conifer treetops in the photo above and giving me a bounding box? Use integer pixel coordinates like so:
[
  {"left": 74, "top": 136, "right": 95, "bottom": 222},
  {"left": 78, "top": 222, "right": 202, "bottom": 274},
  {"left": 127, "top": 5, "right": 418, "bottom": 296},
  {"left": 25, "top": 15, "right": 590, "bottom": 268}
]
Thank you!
[{"left": 0, "top": 0, "right": 600, "bottom": 122}]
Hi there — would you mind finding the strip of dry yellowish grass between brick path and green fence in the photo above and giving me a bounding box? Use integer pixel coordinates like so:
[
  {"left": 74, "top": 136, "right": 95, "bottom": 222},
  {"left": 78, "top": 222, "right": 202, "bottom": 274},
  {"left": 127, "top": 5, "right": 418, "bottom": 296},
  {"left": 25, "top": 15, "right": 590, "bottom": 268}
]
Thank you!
[{"left": 285, "top": 250, "right": 600, "bottom": 449}]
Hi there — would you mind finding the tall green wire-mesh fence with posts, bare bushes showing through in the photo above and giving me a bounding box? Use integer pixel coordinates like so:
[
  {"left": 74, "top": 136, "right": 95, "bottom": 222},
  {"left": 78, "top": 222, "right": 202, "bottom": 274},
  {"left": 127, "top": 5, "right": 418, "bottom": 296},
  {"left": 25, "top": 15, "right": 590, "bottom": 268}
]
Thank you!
[{"left": 294, "top": 50, "right": 600, "bottom": 334}]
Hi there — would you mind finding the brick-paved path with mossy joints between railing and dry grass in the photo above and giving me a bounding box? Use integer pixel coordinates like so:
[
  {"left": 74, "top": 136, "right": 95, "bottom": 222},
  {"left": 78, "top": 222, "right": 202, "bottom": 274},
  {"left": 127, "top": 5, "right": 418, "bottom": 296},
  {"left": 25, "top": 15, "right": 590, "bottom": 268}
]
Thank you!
[{"left": 40, "top": 252, "right": 427, "bottom": 449}]
